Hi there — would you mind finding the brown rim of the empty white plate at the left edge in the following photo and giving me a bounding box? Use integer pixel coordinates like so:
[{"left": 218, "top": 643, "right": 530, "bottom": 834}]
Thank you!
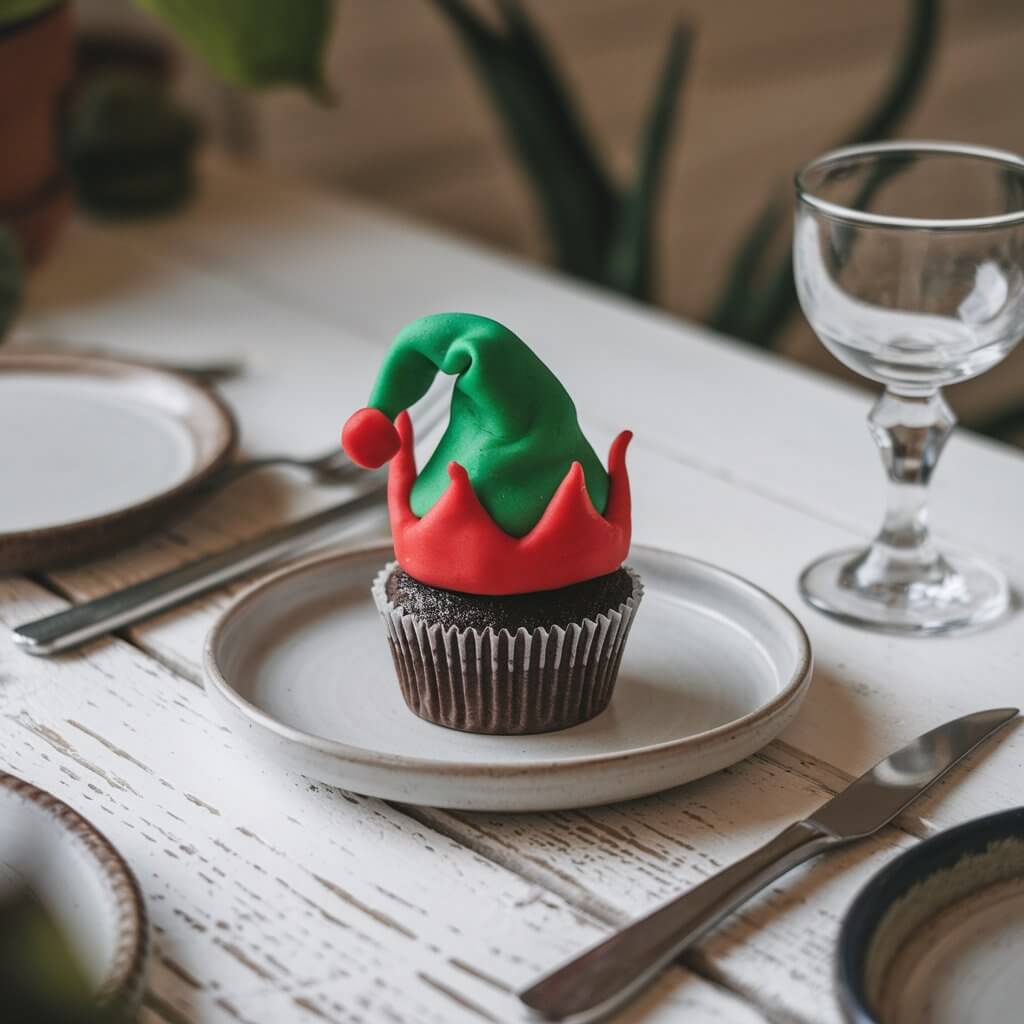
[{"left": 0, "top": 351, "right": 239, "bottom": 553}]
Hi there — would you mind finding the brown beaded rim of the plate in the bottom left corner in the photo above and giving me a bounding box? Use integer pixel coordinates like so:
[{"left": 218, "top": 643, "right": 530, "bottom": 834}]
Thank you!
[{"left": 0, "top": 769, "right": 150, "bottom": 1010}]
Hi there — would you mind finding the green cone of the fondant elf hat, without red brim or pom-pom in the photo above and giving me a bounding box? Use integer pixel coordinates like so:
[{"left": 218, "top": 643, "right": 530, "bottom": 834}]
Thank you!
[{"left": 356, "top": 313, "right": 608, "bottom": 537}]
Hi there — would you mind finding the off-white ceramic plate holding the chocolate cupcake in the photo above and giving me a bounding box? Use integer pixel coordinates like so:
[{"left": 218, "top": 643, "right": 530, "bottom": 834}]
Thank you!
[{"left": 205, "top": 545, "right": 811, "bottom": 811}]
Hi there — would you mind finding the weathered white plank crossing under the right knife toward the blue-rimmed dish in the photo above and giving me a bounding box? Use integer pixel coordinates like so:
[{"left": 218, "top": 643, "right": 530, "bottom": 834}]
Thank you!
[{"left": 414, "top": 739, "right": 1020, "bottom": 1024}]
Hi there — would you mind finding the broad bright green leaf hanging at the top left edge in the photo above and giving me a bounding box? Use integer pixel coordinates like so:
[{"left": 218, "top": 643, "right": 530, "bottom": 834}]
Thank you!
[{"left": 136, "top": 0, "right": 333, "bottom": 98}]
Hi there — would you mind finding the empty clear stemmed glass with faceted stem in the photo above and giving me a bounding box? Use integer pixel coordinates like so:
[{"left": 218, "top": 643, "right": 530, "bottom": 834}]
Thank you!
[{"left": 793, "top": 142, "right": 1024, "bottom": 633}]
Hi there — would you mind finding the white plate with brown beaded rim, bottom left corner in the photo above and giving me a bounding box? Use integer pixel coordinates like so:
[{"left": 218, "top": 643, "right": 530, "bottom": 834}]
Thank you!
[{"left": 0, "top": 772, "right": 148, "bottom": 1019}]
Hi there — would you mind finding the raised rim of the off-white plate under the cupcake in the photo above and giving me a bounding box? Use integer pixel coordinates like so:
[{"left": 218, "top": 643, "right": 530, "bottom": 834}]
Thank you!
[{"left": 203, "top": 542, "right": 814, "bottom": 779}]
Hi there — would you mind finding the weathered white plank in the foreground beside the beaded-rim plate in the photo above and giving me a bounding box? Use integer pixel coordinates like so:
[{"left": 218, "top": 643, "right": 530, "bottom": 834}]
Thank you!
[{"left": 0, "top": 581, "right": 760, "bottom": 1022}]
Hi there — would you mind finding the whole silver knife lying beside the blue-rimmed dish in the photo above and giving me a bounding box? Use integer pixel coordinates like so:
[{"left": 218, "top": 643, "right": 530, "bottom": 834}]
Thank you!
[{"left": 519, "top": 708, "right": 1018, "bottom": 1024}]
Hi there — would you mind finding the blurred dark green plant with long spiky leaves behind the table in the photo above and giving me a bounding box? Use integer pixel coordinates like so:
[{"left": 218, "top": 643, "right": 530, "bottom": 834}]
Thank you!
[{"left": 434, "top": 0, "right": 940, "bottom": 323}]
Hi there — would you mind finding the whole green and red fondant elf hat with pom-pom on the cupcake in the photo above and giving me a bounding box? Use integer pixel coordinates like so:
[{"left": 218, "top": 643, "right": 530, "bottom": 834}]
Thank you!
[{"left": 342, "top": 313, "right": 631, "bottom": 595}]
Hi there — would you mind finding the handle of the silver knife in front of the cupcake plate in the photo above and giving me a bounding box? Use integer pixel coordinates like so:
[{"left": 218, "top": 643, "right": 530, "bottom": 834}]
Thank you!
[{"left": 519, "top": 821, "right": 839, "bottom": 1024}]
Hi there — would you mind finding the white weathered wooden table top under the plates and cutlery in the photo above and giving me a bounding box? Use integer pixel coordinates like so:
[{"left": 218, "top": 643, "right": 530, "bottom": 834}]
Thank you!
[{"left": 0, "top": 159, "right": 1024, "bottom": 1024}]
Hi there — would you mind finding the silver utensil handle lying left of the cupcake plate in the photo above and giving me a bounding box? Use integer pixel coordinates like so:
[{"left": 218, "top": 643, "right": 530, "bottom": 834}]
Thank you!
[{"left": 11, "top": 474, "right": 387, "bottom": 655}]
